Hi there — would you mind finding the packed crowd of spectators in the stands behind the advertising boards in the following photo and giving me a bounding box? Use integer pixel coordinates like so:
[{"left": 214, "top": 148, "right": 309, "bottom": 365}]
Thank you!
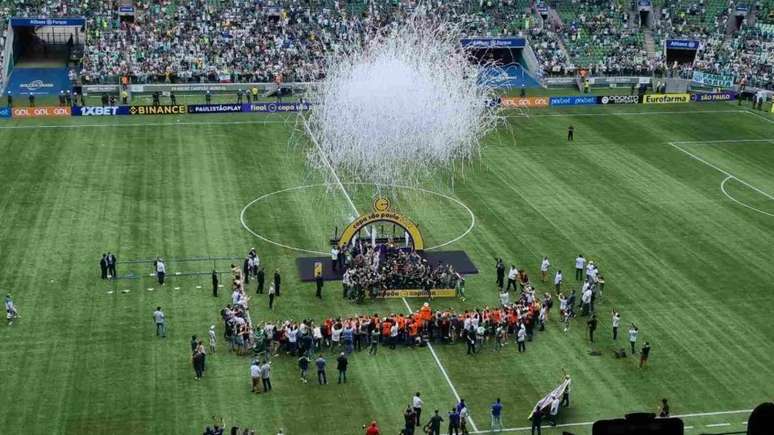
[{"left": 0, "top": 0, "right": 774, "bottom": 88}]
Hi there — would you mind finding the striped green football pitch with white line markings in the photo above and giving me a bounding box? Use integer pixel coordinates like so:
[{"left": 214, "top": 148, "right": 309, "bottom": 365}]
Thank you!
[{"left": 0, "top": 103, "right": 774, "bottom": 435}]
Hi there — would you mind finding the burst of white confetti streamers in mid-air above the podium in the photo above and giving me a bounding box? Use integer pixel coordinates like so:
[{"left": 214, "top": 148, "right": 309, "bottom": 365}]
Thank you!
[{"left": 301, "top": 18, "right": 497, "bottom": 191}]
